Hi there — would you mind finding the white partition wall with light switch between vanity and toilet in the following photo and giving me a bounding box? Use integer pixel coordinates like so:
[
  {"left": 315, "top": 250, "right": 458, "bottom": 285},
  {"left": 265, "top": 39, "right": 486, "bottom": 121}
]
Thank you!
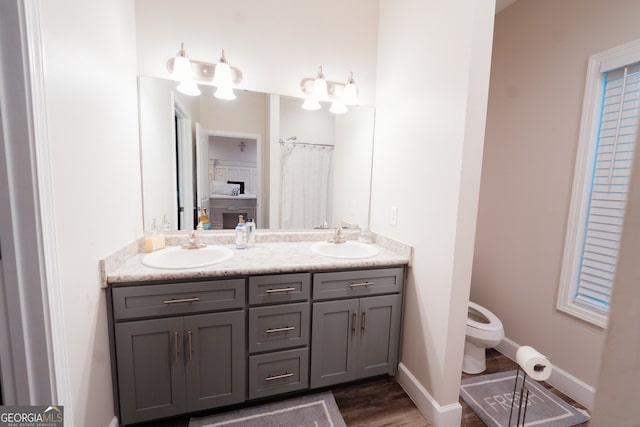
[{"left": 371, "top": 0, "right": 495, "bottom": 426}]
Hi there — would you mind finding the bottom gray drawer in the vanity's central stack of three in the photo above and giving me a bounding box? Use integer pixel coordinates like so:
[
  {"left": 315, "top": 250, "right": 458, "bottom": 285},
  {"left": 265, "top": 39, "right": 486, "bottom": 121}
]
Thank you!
[{"left": 249, "top": 348, "right": 309, "bottom": 399}]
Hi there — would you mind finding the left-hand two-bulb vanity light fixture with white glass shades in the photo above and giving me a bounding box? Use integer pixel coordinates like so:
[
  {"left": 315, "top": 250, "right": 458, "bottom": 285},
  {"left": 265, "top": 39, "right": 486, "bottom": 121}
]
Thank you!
[{"left": 167, "top": 43, "right": 242, "bottom": 100}]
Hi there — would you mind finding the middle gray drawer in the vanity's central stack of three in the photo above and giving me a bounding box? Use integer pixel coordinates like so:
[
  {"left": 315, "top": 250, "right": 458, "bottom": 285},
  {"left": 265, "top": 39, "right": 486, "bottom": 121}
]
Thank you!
[{"left": 249, "top": 302, "right": 310, "bottom": 353}]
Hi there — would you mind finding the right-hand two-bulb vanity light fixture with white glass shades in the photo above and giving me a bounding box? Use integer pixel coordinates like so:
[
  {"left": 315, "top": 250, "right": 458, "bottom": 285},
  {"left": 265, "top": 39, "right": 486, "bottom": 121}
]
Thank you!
[{"left": 300, "top": 67, "right": 358, "bottom": 114}]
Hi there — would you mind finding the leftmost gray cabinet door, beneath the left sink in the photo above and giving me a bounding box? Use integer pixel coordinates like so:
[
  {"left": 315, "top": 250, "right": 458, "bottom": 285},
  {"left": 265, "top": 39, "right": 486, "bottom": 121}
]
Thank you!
[{"left": 115, "top": 318, "right": 186, "bottom": 424}]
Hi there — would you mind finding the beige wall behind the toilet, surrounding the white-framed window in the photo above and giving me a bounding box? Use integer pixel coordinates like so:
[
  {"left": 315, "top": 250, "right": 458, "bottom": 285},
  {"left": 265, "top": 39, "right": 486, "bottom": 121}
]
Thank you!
[{"left": 471, "top": 0, "right": 640, "bottom": 392}]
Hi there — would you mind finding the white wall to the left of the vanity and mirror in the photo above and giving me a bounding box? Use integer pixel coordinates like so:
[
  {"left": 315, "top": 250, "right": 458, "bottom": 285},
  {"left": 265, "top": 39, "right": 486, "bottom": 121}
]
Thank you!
[{"left": 37, "top": 0, "right": 142, "bottom": 426}]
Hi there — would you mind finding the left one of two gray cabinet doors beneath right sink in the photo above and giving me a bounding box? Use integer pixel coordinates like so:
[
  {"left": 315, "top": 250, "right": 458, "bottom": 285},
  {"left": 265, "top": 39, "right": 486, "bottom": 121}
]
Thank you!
[{"left": 311, "top": 299, "right": 359, "bottom": 388}]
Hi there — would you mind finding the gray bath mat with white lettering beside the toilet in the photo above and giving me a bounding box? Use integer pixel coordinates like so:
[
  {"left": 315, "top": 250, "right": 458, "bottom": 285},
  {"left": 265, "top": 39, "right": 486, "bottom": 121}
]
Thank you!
[{"left": 460, "top": 370, "right": 589, "bottom": 427}]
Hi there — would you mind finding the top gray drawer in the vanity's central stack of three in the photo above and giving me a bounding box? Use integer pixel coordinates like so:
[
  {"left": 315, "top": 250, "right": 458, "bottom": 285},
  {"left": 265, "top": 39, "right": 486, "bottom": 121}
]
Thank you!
[{"left": 249, "top": 273, "right": 311, "bottom": 305}]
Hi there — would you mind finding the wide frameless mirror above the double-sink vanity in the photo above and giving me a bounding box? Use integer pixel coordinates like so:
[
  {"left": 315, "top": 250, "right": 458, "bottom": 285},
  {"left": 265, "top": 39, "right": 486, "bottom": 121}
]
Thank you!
[{"left": 138, "top": 77, "right": 374, "bottom": 229}]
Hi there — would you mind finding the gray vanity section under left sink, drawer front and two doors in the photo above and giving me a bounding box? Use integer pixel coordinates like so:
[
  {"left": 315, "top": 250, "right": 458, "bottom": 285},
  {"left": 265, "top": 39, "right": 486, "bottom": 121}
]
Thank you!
[{"left": 111, "top": 279, "right": 246, "bottom": 425}]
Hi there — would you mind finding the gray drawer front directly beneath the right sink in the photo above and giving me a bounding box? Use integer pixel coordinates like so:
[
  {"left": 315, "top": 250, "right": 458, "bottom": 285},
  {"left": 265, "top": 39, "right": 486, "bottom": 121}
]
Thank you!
[{"left": 313, "top": 267, "right": 404, "bottom": 300}]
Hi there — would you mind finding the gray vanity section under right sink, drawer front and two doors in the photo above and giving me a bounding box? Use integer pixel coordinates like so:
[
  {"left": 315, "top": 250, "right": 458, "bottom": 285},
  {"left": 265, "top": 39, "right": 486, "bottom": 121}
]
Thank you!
[{"left": 310, "top": 268, "right": 404, "bottom": 388}]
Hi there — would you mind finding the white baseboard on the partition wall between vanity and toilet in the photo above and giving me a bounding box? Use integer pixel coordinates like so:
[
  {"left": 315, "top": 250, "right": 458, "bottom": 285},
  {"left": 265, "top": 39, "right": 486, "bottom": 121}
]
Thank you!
[{"left": 396, "top": 363, "right": 462, "bottom": 427}]
